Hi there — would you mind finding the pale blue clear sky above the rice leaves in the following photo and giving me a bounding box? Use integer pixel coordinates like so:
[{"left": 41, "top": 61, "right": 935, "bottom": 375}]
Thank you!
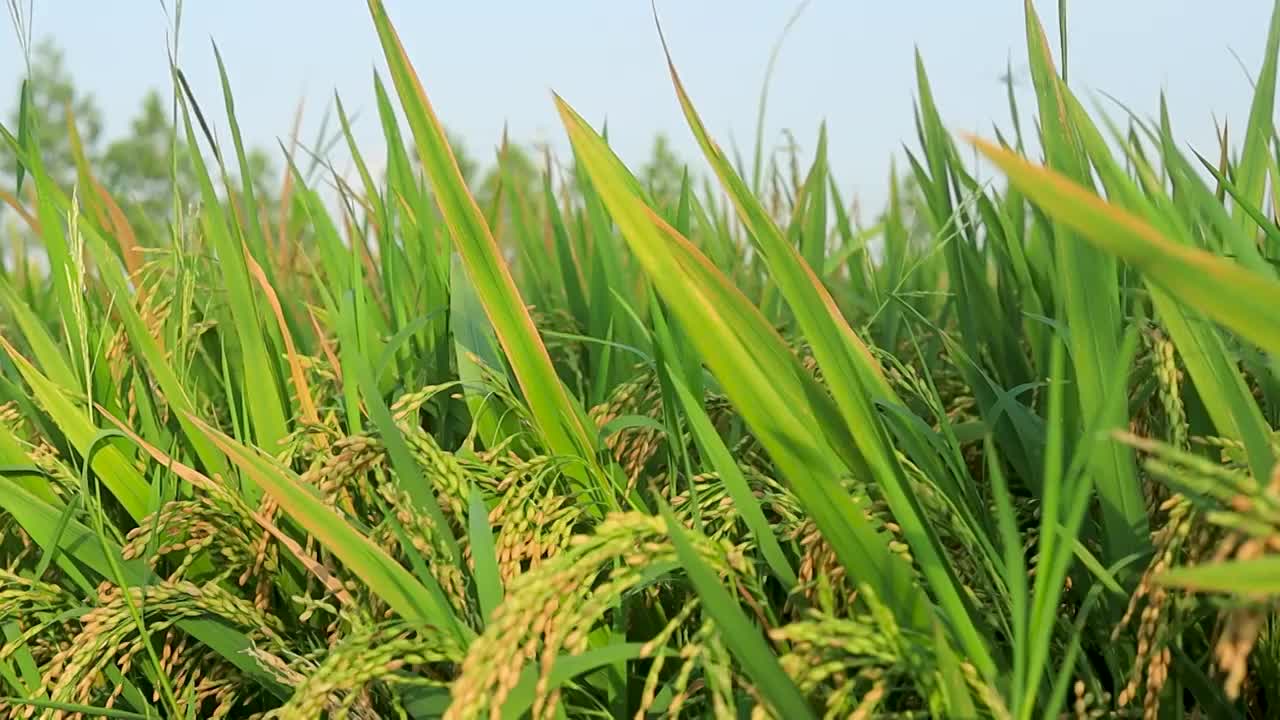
[{"left": 0, "top": 0, "right": 1271, "bottom": 209}]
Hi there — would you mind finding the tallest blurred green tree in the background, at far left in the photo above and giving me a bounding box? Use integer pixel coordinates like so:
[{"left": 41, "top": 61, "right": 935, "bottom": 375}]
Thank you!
[{"left": 0, "top": 38, "right": 102, "bottom": 187}]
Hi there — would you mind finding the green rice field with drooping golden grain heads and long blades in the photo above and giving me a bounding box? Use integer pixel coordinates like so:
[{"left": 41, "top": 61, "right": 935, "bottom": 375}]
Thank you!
[{"left": 0, "top": 0, "right": 1280, "bottom": 720}]
